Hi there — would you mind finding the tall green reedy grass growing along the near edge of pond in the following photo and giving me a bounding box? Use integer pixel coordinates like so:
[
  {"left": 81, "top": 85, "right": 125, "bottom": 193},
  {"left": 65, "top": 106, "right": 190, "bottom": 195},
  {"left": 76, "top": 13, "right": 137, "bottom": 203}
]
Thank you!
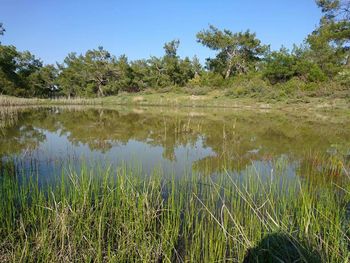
[{"left": 0, "top": 160, "right": 350, "bottom": 262}]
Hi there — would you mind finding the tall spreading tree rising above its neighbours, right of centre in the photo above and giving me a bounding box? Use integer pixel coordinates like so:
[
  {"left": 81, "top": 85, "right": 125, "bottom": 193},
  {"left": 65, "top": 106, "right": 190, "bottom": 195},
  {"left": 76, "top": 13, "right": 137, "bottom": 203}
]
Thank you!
[{"left": 197, "top": 25, "right": 268, "bottom": 79}]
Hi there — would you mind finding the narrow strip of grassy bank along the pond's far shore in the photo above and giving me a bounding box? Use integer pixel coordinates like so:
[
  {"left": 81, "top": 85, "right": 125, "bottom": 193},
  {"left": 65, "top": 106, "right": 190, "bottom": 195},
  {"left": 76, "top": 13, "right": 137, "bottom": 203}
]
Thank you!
[{"left": 0, "top": 90, "right": 350, "bottom": 109}]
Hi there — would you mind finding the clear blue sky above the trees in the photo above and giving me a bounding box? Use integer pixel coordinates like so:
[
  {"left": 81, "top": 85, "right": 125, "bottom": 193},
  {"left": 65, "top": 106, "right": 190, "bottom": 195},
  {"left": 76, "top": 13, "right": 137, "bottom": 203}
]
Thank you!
[{"left": 0, "top": 0, "right": 321, "bottom": 63}]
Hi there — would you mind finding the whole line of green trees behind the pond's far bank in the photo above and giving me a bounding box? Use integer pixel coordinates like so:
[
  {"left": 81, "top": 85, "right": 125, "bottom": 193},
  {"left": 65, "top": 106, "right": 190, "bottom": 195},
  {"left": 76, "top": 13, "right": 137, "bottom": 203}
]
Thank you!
[{"left": 0, "top": 0, "right": 350, "bottom": 98}]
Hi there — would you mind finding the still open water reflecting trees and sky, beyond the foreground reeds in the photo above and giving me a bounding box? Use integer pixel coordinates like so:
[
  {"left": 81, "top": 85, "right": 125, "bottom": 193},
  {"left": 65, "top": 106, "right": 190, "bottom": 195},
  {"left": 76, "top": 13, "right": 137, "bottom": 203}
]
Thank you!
[{"left": 0, "top": 107, "right": 350, "bottom": 183}]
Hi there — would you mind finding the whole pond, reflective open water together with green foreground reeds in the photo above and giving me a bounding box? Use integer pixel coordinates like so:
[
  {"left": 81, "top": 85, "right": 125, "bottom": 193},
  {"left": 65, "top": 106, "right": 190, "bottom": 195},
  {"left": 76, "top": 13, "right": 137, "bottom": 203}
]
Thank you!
[{"left": 0, "top": 106, "right": 350, "bottom": 262}]
